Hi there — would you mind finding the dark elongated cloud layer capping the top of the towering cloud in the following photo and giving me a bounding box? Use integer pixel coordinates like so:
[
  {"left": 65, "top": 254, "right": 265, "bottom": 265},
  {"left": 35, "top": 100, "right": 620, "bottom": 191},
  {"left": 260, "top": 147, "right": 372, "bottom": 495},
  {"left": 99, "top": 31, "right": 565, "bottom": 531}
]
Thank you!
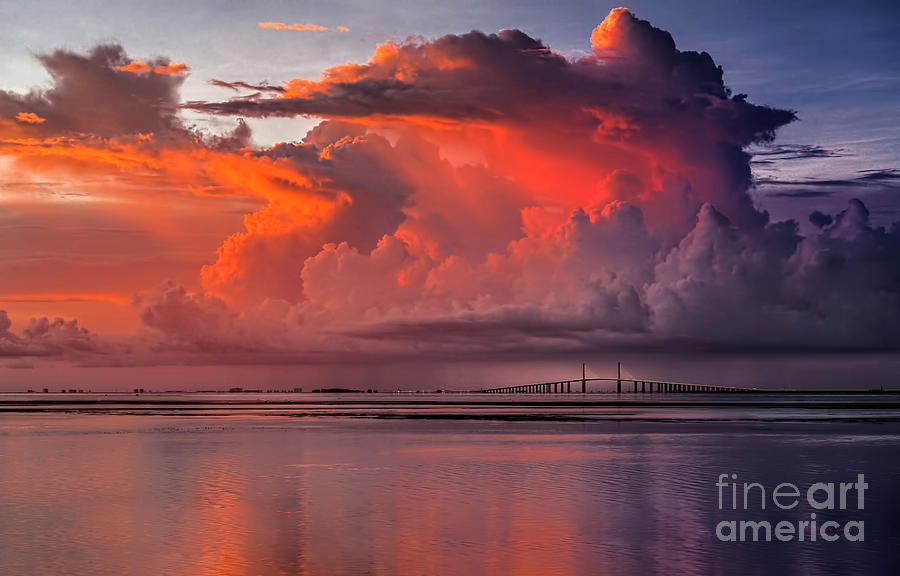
[{"left": 187, "top": 23, "right": 795, "bottom": 143}]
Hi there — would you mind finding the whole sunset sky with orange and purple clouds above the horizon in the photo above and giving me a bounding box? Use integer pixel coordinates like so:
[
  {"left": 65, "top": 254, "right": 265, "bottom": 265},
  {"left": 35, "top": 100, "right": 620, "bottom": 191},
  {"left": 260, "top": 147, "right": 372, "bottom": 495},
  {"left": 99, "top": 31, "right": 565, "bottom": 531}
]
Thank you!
[{"left": 0, "top": 1, "right": 900, "bottom": 390}]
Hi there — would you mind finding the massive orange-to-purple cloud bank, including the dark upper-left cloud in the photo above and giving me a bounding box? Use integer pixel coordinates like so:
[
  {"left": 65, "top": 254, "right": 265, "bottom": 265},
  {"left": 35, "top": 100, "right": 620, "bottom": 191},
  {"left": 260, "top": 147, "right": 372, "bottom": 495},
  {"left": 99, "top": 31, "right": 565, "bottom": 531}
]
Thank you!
[{"left": 0, "top": 8, "right": 900, "bottom": 358}]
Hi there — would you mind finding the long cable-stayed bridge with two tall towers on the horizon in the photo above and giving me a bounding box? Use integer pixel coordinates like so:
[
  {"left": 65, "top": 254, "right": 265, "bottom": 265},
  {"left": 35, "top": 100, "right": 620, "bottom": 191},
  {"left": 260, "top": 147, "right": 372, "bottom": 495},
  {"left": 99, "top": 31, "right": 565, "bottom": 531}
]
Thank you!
[{"left": 475, "top": 362, "right": 757, "bottom": 394}]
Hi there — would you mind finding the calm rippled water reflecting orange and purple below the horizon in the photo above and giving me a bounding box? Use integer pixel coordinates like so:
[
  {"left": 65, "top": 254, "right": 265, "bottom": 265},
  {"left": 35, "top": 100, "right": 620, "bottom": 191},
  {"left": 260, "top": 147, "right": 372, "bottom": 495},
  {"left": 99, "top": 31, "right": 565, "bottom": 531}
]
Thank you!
[{"left": 0, "top": 395, "right": 900, "bottom": 575}]
